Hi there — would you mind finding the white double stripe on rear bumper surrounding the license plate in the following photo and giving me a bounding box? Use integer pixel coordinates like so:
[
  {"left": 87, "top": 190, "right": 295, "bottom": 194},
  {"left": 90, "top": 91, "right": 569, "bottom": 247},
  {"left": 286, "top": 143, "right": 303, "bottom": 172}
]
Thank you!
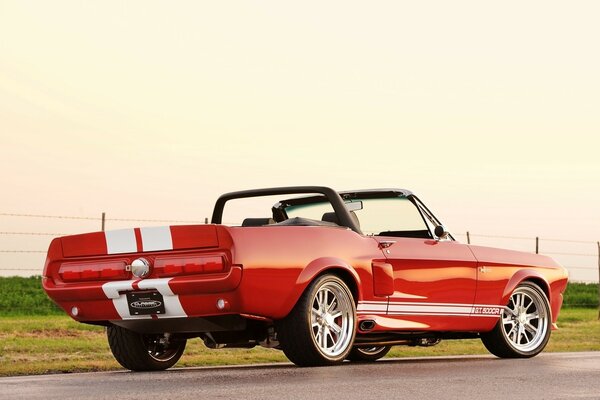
[{"left": 102, "top": 278, "right": 187, "bottom": 320}]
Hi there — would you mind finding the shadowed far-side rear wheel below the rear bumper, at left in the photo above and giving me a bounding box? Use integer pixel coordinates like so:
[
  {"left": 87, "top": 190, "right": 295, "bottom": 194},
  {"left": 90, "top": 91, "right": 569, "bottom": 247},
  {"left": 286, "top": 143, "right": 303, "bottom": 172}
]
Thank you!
[{"left": 106, "top": 325, "right": 186, "bottom": 371}]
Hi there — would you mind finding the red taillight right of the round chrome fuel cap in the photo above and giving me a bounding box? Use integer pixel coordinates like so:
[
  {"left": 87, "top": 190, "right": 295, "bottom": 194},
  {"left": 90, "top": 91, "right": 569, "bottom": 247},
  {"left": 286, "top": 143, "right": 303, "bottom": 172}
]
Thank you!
[{"left": 154, "top": 256, "right": 226, "bottom": 276}]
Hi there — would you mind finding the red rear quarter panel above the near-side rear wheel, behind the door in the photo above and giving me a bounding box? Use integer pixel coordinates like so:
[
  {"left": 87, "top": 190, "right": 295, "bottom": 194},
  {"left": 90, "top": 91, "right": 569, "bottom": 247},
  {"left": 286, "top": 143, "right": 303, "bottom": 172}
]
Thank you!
[{"left": 228, "top": 226, "right": 381, "bottom": 319}]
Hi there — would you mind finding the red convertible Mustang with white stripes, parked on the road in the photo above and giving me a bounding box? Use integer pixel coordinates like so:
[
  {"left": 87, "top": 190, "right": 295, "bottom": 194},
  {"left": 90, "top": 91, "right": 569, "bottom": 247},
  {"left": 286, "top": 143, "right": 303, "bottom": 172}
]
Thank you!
[{"left": 43, "top": 186, "right": 567, "bottom": 371}]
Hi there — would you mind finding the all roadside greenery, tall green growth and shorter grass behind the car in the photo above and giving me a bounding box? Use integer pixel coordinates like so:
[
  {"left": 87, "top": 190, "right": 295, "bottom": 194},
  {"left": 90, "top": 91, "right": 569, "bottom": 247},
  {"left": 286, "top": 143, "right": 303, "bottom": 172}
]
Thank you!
[{"left": 0, "top": 276, "right": 600, "bottom": 376}]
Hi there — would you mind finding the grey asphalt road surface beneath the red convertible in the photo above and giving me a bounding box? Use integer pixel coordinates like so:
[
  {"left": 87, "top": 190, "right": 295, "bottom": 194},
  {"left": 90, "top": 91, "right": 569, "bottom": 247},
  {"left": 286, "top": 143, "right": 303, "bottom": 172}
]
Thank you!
[{"left": 0, "top": 352, "right": 600, "bottom": 400}]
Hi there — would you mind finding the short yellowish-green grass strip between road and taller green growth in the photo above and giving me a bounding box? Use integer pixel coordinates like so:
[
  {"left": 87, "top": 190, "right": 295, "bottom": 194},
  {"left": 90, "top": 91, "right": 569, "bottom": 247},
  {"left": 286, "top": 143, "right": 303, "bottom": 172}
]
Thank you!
[{"left": 0, "top": 308, "right": 600, "bottom": 376}]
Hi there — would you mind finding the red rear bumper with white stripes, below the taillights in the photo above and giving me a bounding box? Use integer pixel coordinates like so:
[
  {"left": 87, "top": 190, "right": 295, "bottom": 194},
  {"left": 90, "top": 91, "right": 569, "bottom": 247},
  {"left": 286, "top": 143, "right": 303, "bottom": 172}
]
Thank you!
[{"left": 43, "top": 266, "right": 242, "bottom": 322}]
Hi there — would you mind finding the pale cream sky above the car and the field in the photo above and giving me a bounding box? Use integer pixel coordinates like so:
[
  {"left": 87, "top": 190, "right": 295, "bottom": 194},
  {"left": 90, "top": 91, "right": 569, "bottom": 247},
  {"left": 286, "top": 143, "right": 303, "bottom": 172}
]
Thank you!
[{"left": 0, "top": 0, "right": 600, "bottom": 279}]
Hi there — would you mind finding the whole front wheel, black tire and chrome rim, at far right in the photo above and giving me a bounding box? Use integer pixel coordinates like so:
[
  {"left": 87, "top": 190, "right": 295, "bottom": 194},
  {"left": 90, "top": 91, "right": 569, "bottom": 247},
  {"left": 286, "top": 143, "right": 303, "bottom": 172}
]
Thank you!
[{"left": 481, "top": 282, "right": 552, "bottom": 358}]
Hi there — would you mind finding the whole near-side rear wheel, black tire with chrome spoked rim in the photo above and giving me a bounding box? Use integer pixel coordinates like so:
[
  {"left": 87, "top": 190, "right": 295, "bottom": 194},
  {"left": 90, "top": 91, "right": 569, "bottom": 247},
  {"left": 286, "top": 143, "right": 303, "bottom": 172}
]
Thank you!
[{"left": 277, "top": 275, "right": 356, "bottom": 367}]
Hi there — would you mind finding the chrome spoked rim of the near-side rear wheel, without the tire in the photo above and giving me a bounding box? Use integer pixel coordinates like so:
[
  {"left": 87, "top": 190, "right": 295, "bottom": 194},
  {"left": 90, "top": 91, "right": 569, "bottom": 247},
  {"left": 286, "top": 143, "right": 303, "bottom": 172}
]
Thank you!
[{"left": 310, "top": 281, "right": 354, "bottom": 357}]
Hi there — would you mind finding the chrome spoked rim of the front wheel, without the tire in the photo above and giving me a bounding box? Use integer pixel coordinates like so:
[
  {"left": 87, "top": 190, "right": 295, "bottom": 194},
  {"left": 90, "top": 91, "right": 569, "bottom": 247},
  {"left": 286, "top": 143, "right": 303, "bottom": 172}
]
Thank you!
[{"left": 502, "top": 286, "right": 549, "bottom": 352}]
